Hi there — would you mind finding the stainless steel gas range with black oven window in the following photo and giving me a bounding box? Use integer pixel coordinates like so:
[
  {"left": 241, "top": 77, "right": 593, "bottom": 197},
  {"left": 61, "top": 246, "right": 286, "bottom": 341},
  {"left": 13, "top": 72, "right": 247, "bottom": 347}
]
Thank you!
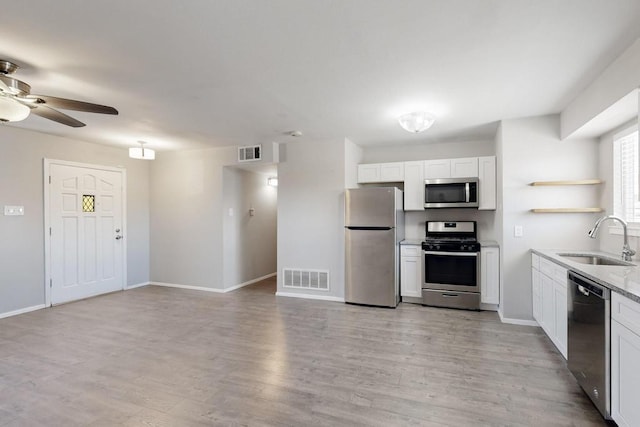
[{"left": 422, "top": 221, "right": 480, "bottom": 310}]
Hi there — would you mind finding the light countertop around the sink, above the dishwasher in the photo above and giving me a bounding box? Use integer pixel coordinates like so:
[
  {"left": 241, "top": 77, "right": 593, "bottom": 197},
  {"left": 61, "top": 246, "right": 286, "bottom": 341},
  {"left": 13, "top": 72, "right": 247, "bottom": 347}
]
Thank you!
[{"left": 531, "top": 249, "right": 640, "bottom": 303}]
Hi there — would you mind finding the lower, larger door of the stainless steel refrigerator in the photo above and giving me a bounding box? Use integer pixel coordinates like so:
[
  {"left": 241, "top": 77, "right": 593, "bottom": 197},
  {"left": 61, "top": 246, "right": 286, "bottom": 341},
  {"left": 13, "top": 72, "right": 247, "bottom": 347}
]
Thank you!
[{"left": 345, "top": 228, "right": 399, "bottom": 307}]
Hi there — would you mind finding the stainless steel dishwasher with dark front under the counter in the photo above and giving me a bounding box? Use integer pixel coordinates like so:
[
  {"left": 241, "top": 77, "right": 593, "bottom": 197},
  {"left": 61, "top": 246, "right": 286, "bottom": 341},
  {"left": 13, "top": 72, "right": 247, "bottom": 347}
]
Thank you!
[{"left": 567, "top": 271, "right": 611, "bottom": 419}]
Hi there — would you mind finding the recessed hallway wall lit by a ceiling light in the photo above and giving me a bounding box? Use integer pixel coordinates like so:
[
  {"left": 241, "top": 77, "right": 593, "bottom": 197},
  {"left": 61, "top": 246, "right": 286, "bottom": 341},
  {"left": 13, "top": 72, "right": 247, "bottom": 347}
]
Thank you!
[{"left": 223, "top": 166, "right": 278, "bottom": 288}]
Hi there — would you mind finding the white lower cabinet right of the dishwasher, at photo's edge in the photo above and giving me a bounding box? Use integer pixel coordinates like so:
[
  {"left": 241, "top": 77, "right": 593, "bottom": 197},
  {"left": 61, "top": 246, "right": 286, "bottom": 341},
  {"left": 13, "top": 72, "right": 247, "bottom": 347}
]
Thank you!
[{"left": 611, "top": 292, "right": 640, "bottom": 427}]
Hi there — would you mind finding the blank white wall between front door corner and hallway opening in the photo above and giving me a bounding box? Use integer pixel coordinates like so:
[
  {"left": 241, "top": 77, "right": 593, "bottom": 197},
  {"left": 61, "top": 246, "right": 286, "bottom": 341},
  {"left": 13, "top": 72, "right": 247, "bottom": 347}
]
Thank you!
[{"left": 150, "top": 147, "right": 237, "bottom": 290}]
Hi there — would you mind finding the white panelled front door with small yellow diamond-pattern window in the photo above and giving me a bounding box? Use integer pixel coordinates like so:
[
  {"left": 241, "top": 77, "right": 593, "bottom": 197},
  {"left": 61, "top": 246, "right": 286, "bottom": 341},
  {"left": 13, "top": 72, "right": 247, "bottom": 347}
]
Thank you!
[{"left": 45, "top": 161, "right": 125, "bottom": 304}]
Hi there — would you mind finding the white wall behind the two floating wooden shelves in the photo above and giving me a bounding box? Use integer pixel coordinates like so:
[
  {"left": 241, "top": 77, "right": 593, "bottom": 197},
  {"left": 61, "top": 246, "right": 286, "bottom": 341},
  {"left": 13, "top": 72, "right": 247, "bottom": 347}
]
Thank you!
[{"left": 497, "top": 115, "right": 600, "bottom": 320}]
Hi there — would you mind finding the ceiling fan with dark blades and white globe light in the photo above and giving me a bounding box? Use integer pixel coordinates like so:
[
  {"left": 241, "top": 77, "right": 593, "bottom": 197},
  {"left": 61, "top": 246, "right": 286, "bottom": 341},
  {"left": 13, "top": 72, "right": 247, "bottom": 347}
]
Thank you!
[{"left": 0, "top": 59, "right": 118, "bottom": 127}]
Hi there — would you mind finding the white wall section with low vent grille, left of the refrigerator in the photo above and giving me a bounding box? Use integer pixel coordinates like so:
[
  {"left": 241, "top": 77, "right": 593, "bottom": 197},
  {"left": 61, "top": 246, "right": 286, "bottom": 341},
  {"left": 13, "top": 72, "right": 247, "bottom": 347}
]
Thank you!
[{"left": 278, "top": 140, "right": 348, "bottom": 299}]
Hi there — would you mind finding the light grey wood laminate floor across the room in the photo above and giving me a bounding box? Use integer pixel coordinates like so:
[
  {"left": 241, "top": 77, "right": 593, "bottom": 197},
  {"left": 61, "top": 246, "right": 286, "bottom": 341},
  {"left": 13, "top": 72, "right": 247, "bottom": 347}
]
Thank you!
[{"left": 0, "top": 279, "right": 605, "bottom": 426}]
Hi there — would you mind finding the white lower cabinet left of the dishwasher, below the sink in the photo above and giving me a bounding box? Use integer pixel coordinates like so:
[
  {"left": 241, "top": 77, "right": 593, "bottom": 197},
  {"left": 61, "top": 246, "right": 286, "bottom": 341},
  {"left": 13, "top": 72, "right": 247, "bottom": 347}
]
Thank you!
[{"left": 531, "top": 254, "right": 568, "bottom": 359}]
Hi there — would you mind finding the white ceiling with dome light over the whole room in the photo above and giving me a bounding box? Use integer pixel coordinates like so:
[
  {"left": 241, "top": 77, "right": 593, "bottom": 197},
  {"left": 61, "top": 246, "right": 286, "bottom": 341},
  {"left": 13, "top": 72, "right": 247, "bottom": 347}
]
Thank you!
[{"left": 0, "top": 0, "right": 640, "bottom": 150}]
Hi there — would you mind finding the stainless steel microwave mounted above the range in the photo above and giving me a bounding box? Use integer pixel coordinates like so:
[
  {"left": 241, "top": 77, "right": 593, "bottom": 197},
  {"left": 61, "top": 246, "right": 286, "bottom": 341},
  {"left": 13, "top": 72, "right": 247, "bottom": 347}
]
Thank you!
[{"left": 424, "top": 178, "right": 478, "bottom": 209}]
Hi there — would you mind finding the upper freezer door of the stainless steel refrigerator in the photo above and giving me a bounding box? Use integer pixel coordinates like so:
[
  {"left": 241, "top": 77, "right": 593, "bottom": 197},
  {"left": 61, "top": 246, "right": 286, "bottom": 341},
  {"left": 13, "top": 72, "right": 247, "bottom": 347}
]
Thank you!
[{"left": 344, "top": 187, "right": 402, "bottom": 227}]
